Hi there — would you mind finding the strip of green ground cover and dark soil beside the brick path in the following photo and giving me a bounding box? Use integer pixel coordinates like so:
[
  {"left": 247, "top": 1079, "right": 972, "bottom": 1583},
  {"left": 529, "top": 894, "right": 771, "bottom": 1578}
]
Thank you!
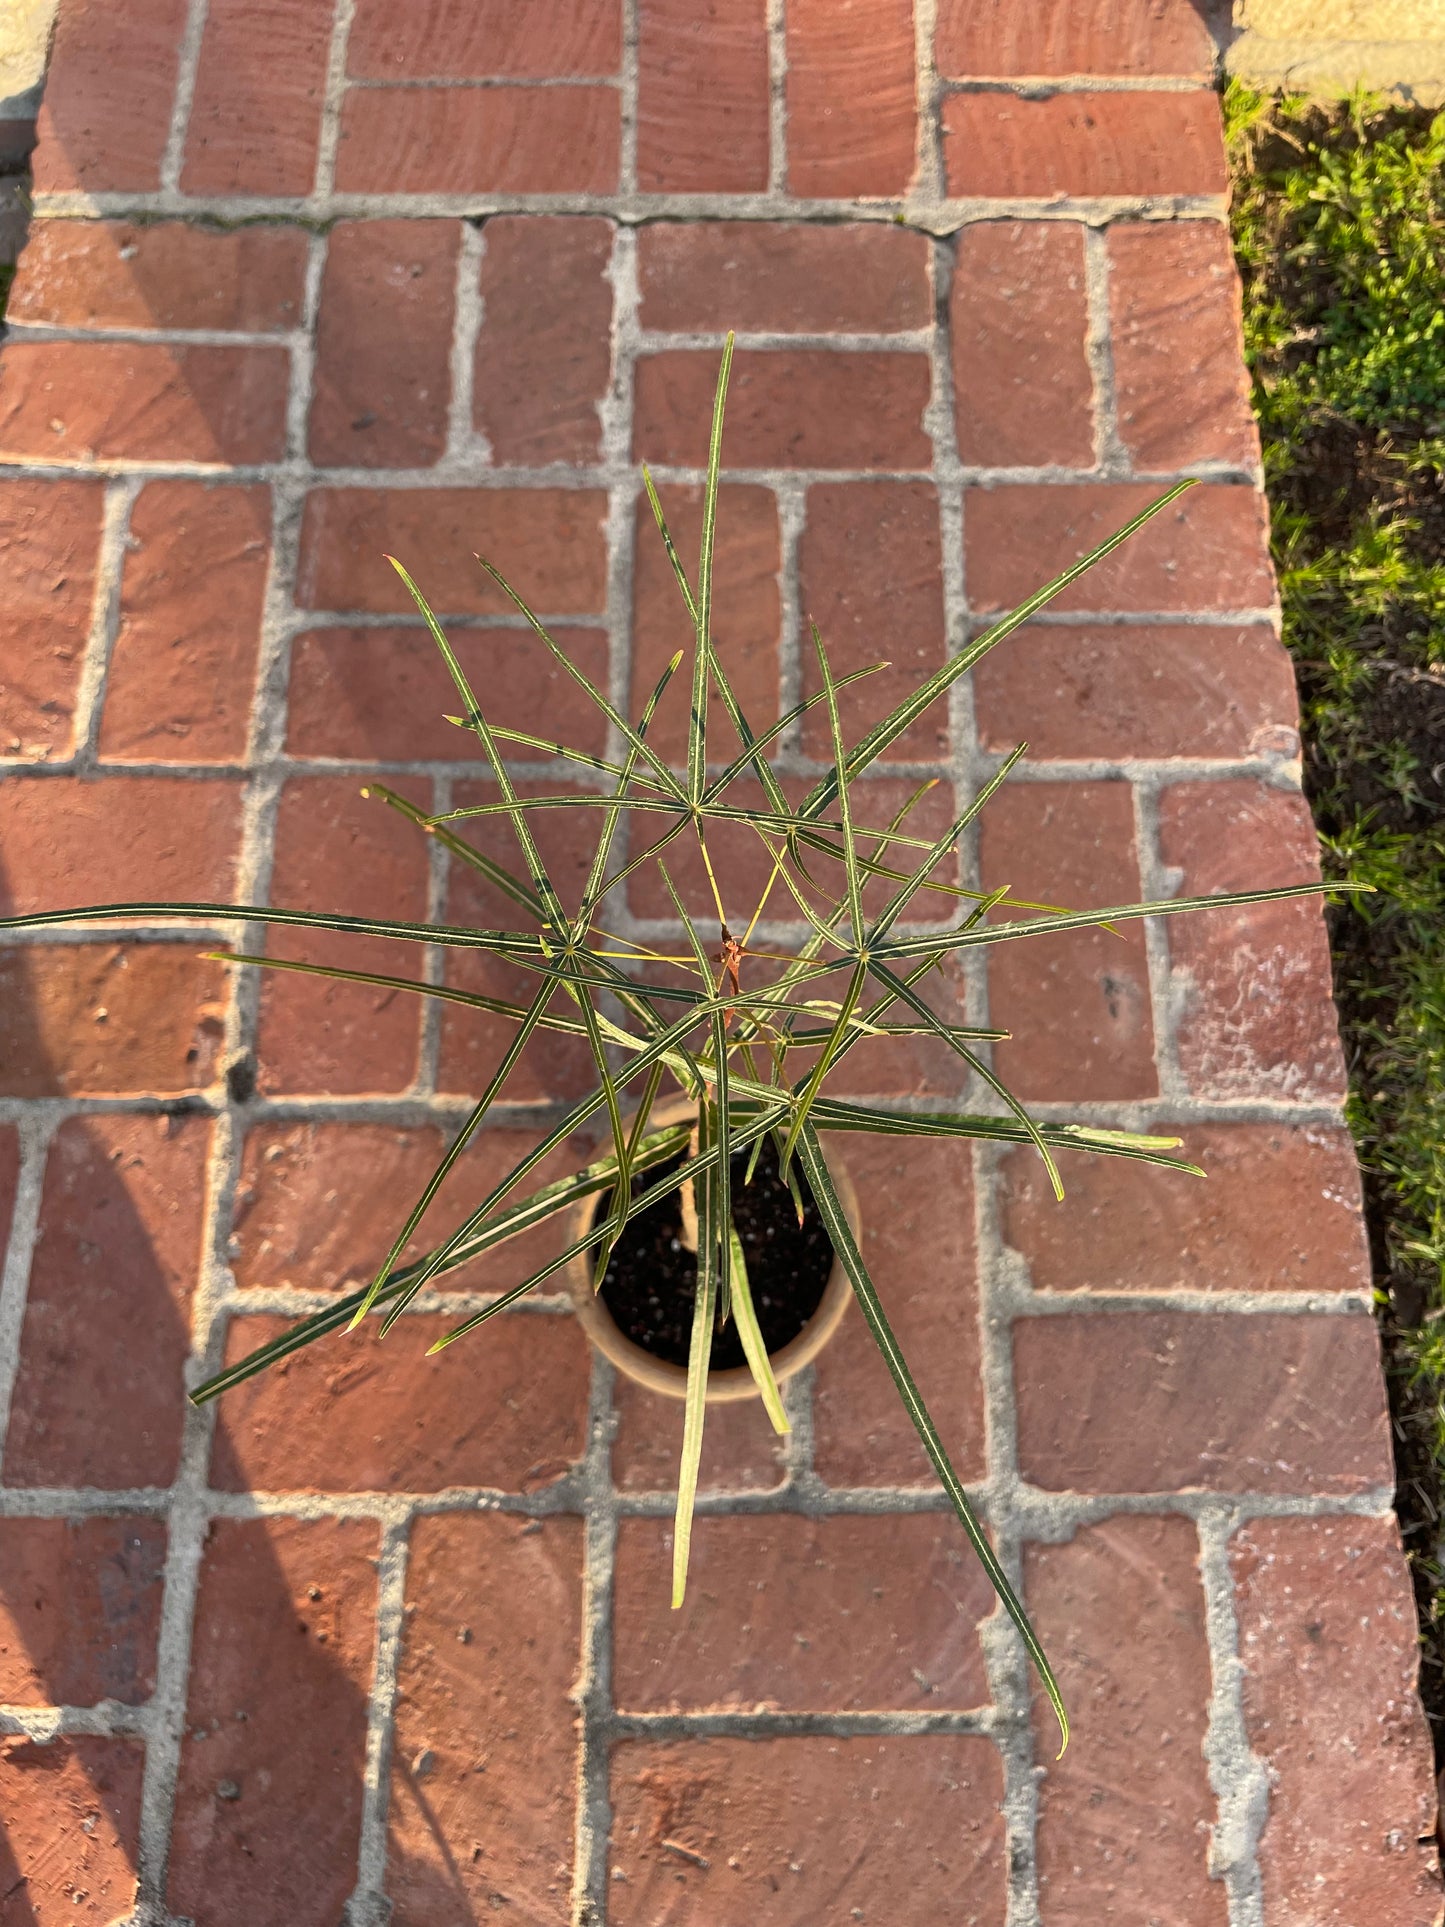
[{"left": 1225, "top": 83, "right": 1445, "bottom": 1752}]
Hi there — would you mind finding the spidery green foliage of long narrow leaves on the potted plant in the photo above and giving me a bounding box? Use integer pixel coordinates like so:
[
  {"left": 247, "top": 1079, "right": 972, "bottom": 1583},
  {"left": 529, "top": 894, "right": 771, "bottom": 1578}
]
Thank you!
[{"left": 4, "top": 341, "right": 1348, "bottom": 1734}]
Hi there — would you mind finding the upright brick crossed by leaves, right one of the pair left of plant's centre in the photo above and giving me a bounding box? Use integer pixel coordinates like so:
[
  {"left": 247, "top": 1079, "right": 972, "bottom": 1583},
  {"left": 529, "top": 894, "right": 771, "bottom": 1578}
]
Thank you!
[{"left": 439, "top": 782, "right": 601, "bottom": 1104}]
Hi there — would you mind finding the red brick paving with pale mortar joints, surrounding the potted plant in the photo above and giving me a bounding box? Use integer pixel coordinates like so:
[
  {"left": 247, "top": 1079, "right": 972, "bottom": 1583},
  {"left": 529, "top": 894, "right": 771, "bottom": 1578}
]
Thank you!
[{"left": 0, "top": 0, "right": 1439, "bottom": 1927}]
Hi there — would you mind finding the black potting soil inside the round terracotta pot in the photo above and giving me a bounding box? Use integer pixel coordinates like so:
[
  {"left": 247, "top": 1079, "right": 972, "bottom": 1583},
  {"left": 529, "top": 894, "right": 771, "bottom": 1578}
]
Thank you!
[{"left": 593, "top": 1141, "right": 832, "bottom": 1372}]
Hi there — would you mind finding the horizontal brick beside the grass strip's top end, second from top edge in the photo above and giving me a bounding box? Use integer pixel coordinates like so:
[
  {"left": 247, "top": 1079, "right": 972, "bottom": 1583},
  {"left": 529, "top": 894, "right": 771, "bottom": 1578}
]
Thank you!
[{"left": 942, "top": 89, "right": 1227, "bottom": 198}]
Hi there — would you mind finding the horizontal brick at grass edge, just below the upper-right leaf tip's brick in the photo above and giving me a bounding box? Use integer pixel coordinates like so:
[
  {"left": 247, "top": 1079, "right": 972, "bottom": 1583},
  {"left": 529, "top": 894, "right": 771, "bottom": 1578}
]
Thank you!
[{"left": 973, "top": 622, "right": 1299, "bottom": 761}]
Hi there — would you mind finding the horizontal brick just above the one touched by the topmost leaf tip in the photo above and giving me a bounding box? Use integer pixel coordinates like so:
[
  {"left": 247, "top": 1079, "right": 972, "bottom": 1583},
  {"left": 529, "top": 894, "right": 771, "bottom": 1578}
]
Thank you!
[{"left": 638, "top": 222, "right": 933, "bottom": 335}]
